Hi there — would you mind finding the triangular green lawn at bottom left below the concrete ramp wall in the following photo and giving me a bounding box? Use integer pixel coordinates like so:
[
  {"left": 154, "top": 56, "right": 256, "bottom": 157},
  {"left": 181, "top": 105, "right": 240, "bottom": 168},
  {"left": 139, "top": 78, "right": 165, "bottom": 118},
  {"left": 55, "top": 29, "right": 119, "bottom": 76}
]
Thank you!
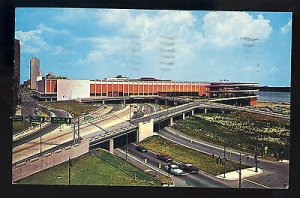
[{"left": 17, "top": 149, "right": 160, "bottom": 186}]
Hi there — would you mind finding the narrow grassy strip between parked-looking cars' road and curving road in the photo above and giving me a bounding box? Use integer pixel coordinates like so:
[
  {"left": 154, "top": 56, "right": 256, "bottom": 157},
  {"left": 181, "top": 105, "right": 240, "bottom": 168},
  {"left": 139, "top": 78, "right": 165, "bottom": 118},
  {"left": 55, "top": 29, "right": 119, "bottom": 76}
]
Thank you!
[{"left": 140, "top": 136, "right": 249, "bottom": 175}]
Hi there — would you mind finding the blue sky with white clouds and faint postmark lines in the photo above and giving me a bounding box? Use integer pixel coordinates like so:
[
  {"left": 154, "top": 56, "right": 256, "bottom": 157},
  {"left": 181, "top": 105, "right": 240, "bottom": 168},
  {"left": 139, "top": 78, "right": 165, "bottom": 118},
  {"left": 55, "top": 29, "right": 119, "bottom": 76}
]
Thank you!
[{"left": 15, "top": 8, "right": 292, "bottom": 86}]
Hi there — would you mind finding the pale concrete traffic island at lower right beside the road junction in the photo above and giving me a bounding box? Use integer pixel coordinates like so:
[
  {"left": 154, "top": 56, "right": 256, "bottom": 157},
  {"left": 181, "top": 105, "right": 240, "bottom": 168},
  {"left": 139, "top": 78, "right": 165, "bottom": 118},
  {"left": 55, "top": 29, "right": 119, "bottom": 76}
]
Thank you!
[{"left": 216, "top": 167, "right": 263, "bottom": 180}]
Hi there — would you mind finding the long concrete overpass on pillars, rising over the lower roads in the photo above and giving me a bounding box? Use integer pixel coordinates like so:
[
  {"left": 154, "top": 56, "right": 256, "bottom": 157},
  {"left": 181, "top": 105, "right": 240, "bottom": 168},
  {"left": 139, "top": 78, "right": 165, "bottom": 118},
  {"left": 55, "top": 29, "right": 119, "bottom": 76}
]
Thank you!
[{"left": 15, "top": 97, "right": 290, "bottom": 167}]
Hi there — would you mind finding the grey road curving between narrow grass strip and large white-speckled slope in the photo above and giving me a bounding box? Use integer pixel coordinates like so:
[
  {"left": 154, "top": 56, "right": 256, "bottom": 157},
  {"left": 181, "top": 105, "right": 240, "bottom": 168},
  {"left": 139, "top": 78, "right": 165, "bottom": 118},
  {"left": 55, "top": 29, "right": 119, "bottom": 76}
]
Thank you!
[{"left": 159, "top": 129, "right": 289, "bottom": 188}]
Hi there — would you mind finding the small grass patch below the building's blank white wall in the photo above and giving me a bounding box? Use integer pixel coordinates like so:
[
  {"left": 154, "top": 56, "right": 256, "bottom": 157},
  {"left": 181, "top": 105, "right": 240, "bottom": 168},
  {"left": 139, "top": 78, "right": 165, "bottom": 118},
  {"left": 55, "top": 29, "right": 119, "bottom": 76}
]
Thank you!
[{"left": 41, "top": 101, "right": 98, "bottom": 117}]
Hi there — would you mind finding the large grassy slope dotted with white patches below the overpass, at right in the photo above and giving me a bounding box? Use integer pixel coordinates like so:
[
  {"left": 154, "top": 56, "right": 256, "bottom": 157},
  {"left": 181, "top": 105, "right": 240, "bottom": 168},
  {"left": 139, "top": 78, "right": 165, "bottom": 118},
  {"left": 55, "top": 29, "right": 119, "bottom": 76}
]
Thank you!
[{"left": 173, "top": 112, "right": 290, "bottom": 159}]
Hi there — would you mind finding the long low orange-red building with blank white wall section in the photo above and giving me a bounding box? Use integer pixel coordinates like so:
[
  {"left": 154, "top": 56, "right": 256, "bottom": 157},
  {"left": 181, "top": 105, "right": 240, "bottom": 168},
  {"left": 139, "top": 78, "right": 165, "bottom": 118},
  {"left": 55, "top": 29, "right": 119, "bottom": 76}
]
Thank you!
[{"left": 36, "top": 74, "right": 258, "bottom": 103}]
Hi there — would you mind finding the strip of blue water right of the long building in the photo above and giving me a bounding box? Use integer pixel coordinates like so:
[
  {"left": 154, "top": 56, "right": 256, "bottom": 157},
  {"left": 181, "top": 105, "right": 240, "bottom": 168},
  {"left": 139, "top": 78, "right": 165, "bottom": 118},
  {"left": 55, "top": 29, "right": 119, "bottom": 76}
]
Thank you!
[{"left": 258, "top": 91, "right": 291, "bottom": 102}]
